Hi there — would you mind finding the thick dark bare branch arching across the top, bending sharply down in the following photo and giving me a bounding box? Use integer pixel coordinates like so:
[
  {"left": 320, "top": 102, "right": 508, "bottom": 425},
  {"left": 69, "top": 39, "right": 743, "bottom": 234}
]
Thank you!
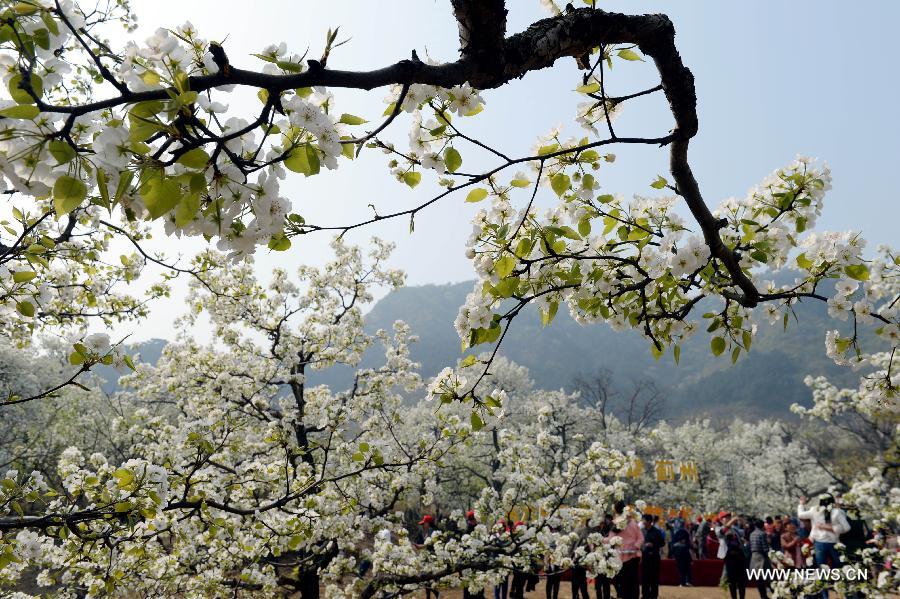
[{"left": 15, "top": 9, "right": 760, "bottom": 307}]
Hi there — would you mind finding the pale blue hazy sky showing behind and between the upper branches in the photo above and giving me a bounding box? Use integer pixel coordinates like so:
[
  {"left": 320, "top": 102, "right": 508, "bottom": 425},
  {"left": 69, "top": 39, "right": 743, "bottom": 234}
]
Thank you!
[{"left": 112, "top": 0, "right": 900, "bottom": 338}]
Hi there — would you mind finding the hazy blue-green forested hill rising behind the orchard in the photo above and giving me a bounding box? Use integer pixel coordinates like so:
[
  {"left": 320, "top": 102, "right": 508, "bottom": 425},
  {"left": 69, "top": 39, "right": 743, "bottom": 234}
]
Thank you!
[{"left": 101, "top": 282, "right": 872, "bottom": 420}]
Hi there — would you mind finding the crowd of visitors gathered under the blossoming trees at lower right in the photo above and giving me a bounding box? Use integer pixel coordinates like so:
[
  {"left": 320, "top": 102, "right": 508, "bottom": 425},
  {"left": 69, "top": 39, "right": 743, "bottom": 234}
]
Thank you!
[{"left": 417, "top": 494, "right": 897, "bottom": 599}]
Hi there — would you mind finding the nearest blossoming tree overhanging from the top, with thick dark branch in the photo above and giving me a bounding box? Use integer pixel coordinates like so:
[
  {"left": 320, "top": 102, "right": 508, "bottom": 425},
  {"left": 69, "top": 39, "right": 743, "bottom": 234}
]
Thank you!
[{"left": 0, "top": 0, "right": 900, "bottom": 402}]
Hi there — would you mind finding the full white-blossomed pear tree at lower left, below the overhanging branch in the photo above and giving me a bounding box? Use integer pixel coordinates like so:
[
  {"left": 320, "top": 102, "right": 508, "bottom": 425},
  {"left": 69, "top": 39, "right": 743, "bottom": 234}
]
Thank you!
[{"left": 0, "top": 240, "right": 625, "bottom": 599}]
